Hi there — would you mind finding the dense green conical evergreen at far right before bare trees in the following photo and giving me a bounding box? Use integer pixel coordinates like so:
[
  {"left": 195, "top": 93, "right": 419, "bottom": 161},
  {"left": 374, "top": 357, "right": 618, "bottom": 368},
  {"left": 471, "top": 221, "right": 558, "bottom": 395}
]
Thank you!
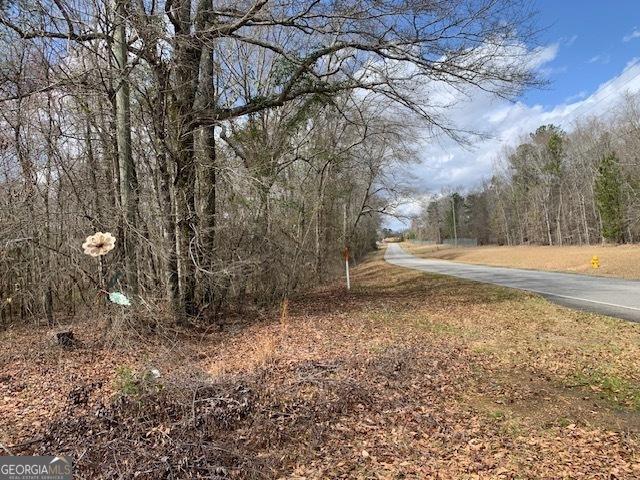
[{"left": 595, "top": 153, "right": 623, "bottom": 242}]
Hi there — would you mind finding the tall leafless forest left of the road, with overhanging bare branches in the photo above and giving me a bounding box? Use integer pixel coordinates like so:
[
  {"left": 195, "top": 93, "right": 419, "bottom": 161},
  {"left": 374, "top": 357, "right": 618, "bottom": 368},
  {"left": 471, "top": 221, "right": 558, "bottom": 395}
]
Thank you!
[{"left": 0, "top": 0, "right": 540, "bottom": 324}]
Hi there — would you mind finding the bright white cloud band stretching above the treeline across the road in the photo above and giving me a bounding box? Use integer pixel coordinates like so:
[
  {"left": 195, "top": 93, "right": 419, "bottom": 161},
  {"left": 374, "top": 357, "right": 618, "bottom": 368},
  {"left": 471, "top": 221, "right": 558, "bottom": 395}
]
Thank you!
[{"left": 412, "top": 60, "right": 640, "bottom": 192}]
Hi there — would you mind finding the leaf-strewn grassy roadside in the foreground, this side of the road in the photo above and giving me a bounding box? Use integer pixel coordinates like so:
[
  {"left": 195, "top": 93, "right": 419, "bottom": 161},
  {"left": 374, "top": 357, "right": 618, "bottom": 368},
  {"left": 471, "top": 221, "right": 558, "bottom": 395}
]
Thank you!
[{"left": 0, "top": 252, "right": 640, "bottom": 479}]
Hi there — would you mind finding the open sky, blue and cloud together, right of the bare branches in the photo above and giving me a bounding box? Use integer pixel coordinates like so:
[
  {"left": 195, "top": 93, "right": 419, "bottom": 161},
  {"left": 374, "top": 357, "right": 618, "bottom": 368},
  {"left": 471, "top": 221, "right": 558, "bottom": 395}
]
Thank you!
[{"left": 389, "top": 0, "right": 640, "bottom": 228}]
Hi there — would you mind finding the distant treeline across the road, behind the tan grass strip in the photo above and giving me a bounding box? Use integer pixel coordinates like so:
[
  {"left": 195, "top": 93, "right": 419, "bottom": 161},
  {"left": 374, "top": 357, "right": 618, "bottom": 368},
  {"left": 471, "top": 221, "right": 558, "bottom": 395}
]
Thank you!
[{"left": 410, "top": 94, "right": 640, "bottom": 245}]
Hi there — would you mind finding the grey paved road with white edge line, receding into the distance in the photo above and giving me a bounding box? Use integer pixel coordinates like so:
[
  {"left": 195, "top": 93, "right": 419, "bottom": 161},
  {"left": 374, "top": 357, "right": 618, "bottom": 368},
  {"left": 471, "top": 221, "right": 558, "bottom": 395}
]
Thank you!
[{"left": 384, "top": 243, "right": 640, "bottom": 322}]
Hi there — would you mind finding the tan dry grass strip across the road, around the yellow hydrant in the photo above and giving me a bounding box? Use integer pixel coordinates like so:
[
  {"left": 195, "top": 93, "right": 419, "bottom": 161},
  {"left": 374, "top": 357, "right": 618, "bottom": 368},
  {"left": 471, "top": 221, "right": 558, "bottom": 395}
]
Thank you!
[{"left": 403, "top": 242, "right": 640, "bottom": 280}]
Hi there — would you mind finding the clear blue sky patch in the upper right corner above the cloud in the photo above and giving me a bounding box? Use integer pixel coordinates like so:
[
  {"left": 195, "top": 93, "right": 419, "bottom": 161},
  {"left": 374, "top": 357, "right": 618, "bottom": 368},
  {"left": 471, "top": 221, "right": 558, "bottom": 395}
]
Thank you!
[{"left": 523, "top": 0, "right": 640, "bottom": 107}]
